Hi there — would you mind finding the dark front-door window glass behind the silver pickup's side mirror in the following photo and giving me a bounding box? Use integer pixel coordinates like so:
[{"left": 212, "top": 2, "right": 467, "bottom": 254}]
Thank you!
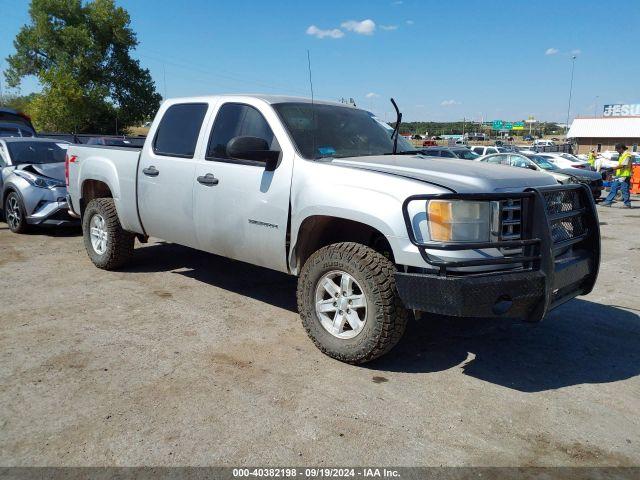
[{"left": 206, "top": 103, "right": 280, "bottom": 159}]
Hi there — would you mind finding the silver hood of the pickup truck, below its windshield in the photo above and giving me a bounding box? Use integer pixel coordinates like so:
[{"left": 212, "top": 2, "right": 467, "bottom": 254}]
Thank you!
[{"left": 331, "top": 155, "right": 558, "bottom": 193}]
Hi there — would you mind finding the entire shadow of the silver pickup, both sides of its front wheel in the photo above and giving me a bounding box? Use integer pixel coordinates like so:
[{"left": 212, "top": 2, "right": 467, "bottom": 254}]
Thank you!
[{"left": 124, "top": 243, "right": 640, "bottom": 392}]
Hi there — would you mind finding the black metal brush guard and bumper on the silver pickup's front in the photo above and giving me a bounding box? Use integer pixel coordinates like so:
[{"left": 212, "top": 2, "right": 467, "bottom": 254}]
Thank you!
[{"left": 396, "top": 185, "right": 600, "bottom": 321}]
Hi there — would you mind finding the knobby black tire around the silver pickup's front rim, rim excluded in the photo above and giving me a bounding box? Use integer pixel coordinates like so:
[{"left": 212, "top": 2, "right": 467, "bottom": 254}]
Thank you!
[{"left": 297, "top": 242, "right": 408, "bottom": 364}]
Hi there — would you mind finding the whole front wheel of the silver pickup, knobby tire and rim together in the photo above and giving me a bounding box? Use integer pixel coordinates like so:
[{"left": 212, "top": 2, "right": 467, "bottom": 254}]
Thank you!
[{"left": 297, "top": 242, "right": 408, "bottom": 364}]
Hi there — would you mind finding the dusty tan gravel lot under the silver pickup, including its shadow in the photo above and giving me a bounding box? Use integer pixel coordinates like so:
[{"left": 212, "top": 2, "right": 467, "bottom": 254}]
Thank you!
[{"left": 0, "top": 203, "right": 640, "bottom": 466}]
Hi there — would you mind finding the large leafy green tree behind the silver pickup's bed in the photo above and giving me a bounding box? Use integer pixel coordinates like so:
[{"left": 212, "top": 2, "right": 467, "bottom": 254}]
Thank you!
[{"left": 5, "top": 0, "right": 161, "bottom": 133}]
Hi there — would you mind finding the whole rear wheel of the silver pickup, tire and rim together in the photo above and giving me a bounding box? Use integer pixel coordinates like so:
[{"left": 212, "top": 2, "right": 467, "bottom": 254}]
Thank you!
[{"left": 82, "top": 198, "right": 135, "bottom": 270}]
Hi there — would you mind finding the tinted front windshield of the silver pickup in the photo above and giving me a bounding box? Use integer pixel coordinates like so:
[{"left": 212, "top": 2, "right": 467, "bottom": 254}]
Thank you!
[{"left": 273, "top": 103, "right": 415, "bottom": 160}]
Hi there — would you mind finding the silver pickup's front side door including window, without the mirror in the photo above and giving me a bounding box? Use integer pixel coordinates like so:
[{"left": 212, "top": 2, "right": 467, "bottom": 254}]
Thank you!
[{"left": 194, "top": 102, "right": 293, "bottom": 272}]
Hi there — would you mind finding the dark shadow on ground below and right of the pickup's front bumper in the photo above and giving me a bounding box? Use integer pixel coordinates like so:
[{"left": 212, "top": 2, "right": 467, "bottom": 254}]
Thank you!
[{"left": 367, "top": 299, "right": 640, "bottom": 392}]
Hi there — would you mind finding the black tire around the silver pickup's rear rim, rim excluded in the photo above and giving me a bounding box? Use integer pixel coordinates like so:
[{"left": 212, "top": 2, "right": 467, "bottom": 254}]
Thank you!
[{"left": 82, "top": 198, "right": 135, "bottom": 270}]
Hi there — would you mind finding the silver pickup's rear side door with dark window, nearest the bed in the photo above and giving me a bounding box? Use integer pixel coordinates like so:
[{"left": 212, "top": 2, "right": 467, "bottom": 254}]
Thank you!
[{"left": 138, "top": 103, "right": 209, "bottom": 247}]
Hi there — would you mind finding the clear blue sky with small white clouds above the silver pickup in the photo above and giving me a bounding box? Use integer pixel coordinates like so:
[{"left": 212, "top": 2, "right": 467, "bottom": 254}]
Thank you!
[{"left": 0, "top": 0, "right": 640, "bottom": 122}]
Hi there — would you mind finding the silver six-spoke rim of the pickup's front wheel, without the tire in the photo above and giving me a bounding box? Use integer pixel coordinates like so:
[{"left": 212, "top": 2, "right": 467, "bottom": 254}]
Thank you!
[{"left": 316, "top": 270, "right": 367, "bottom": 340}]
